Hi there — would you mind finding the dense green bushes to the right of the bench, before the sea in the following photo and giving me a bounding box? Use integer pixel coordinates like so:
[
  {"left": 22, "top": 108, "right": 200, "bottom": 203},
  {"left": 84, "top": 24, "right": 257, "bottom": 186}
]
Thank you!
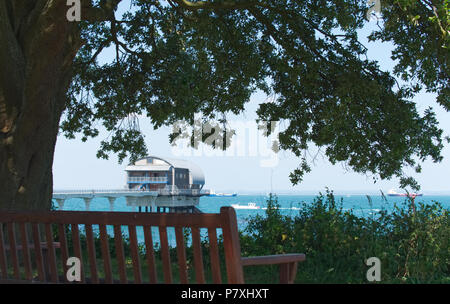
[{"left": 241, "top": 190, "right": 450, "bottom": 283}]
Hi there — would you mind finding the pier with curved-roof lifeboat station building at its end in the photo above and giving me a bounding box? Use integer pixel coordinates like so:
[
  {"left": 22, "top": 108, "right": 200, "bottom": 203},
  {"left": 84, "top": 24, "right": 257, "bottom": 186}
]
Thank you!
[{"left": 53, "top": 156, "right": 206, "bottom": 213}]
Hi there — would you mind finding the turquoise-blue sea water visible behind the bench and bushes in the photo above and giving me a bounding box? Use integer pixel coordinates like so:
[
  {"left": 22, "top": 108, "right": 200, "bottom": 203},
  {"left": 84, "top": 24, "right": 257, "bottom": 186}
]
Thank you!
[{"left": 55, "top": 194, "right": 450, "bottom": 246}]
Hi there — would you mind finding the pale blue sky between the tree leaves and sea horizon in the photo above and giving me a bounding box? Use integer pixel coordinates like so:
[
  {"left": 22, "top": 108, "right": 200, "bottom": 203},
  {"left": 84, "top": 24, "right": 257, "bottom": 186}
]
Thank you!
[{"left": 53, "top": 5, "right": 450, "bottom": 193}]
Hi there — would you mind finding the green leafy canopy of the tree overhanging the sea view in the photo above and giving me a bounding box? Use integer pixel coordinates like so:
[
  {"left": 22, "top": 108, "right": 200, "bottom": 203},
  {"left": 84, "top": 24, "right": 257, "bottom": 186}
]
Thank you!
[{"left": 61, "top": 0, "right": 450, "bottom": 189}]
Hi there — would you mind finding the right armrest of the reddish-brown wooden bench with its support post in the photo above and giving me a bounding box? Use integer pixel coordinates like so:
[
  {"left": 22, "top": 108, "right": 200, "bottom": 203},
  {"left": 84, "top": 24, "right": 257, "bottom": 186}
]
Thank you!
[{"left": 241, "top": 253, "right": 306, "bottom": 284}]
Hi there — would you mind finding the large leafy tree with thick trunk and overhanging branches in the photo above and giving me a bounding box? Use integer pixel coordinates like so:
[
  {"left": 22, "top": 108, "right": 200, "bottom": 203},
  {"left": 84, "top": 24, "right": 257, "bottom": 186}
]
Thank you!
[{"left": 0, "top": 0, "right": 449, "bottom": 209}]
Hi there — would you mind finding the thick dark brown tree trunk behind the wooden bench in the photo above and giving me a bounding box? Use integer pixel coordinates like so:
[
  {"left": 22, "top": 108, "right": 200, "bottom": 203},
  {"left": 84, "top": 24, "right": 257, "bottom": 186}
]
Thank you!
[{"left": 0, "top": 0, "right": 81, "bottom": 210}]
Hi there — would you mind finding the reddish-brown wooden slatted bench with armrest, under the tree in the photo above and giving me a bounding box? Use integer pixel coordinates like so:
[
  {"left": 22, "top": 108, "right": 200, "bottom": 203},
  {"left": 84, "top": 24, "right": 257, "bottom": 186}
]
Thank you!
[{"left": 0, "top": 207, "right": 305, "bottom": 283}]
